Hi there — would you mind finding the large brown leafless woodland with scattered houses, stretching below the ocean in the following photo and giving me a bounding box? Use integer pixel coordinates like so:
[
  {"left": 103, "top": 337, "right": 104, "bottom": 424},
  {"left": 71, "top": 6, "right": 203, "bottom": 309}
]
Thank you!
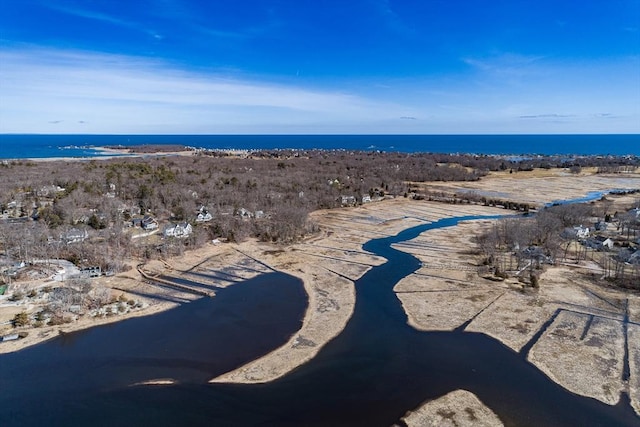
[{"left": 0, "top": 147, "right": 640, "bottom": 280}]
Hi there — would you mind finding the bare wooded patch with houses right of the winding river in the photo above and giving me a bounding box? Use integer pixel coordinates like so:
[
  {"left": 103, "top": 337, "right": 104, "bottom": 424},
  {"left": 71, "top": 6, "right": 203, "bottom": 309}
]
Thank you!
[{"left": 477, "top": 196, "right": 640, "bottom": 289}]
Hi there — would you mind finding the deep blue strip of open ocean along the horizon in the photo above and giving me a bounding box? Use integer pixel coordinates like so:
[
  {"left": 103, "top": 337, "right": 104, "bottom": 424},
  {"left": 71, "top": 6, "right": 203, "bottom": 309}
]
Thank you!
[{"left": 0, "top": 134, "right": 640, "bottom": 159}]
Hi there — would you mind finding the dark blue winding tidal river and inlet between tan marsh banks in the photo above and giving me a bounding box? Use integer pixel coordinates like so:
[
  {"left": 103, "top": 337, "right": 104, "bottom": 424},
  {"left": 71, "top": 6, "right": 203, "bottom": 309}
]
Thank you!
[{"left": 0, "top": 217, "right": 640, "bottom": 427}]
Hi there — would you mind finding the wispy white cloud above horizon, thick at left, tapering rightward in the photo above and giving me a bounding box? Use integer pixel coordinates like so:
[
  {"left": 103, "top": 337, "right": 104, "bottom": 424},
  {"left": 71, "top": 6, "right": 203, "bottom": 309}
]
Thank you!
[{"left": 0, "top": 49, "right": 399, "bottom": 132}]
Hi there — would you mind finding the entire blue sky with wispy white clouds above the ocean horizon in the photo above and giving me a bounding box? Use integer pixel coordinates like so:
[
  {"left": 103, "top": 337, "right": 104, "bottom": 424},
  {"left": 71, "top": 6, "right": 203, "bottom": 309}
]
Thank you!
[{"left": 0, "top": 0, "right": 640, "bottom": 134}]
